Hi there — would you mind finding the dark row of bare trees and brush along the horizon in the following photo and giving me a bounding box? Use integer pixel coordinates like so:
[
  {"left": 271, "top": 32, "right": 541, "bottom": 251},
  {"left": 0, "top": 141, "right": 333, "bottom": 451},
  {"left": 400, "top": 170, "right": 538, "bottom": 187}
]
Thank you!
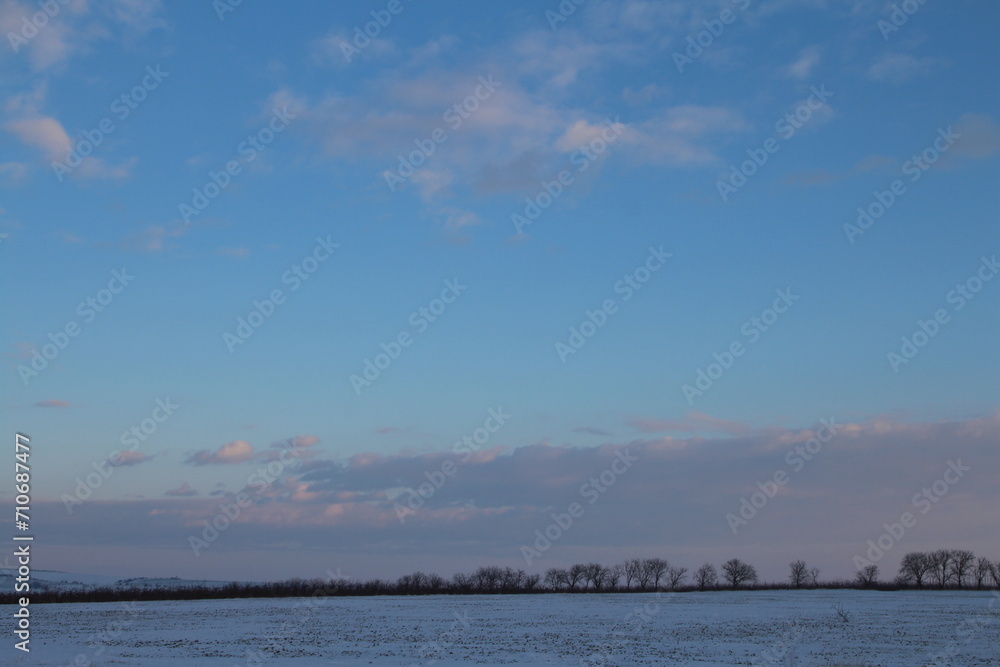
[{"left": 9, "top": 549, "right": 1000, "bottom": 604}]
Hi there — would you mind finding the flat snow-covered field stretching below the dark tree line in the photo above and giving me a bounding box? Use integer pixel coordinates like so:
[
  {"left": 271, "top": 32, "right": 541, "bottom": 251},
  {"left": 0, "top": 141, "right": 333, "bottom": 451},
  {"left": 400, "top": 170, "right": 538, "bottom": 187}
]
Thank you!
[{"left": 0, "top": 591, "right": 1000, "bottom": 667}]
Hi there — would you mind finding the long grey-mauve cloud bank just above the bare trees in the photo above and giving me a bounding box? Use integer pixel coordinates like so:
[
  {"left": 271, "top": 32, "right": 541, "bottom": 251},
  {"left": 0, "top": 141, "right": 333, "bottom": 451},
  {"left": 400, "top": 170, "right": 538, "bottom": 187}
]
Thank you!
[{"left": 27, "top": 414, "right": 1000, "bottom": 579}]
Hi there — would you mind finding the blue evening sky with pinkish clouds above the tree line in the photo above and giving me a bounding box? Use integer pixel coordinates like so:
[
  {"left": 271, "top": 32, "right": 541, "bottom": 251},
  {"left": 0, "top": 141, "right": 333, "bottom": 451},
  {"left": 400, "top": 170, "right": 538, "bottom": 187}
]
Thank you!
[{"left": 0, "top": 0, "right": 1000, "bottom": 580}]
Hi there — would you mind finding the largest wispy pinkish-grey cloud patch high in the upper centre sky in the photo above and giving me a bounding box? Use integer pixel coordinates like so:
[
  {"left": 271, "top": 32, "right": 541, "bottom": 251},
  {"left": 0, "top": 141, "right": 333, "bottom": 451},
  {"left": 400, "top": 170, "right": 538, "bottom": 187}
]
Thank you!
[{"left": 281, "top": 32, "right": 747, "bottom": 204}]
